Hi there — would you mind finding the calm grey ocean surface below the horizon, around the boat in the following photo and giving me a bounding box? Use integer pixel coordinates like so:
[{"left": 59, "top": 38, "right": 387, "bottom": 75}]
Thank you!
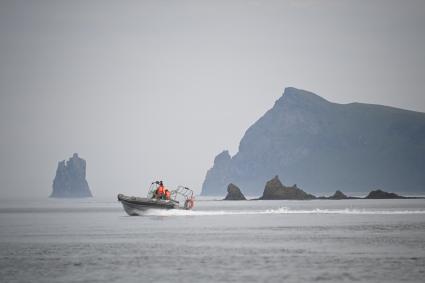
[{"left": 0, "top": 198, "right": 425, "bottom": 282}]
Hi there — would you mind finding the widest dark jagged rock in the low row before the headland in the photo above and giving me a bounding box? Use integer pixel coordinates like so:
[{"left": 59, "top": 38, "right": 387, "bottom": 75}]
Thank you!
[{"left": 260, "top": 176, "right": 316, "bottom": 200}]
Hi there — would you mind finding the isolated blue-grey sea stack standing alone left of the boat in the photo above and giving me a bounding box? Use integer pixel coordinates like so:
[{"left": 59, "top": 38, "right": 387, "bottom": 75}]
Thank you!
[{"left": 50, "top": 153, "right": 92, "bottom": 198}]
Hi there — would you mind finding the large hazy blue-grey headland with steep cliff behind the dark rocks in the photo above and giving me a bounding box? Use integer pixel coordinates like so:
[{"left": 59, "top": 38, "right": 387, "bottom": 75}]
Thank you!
[{"left": 202, "top": 88, "right": 425, "bottom": 195}]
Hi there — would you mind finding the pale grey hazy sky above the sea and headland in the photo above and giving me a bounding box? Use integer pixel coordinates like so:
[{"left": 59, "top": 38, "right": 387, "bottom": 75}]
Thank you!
[{"left": 0, "top": 0, "right": 425, "bottom": 198}]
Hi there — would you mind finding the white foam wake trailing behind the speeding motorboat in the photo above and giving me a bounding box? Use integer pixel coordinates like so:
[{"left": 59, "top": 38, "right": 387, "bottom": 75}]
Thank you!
[{"left": 143, "top": 207, "right": 425, "bottom": 216}]
